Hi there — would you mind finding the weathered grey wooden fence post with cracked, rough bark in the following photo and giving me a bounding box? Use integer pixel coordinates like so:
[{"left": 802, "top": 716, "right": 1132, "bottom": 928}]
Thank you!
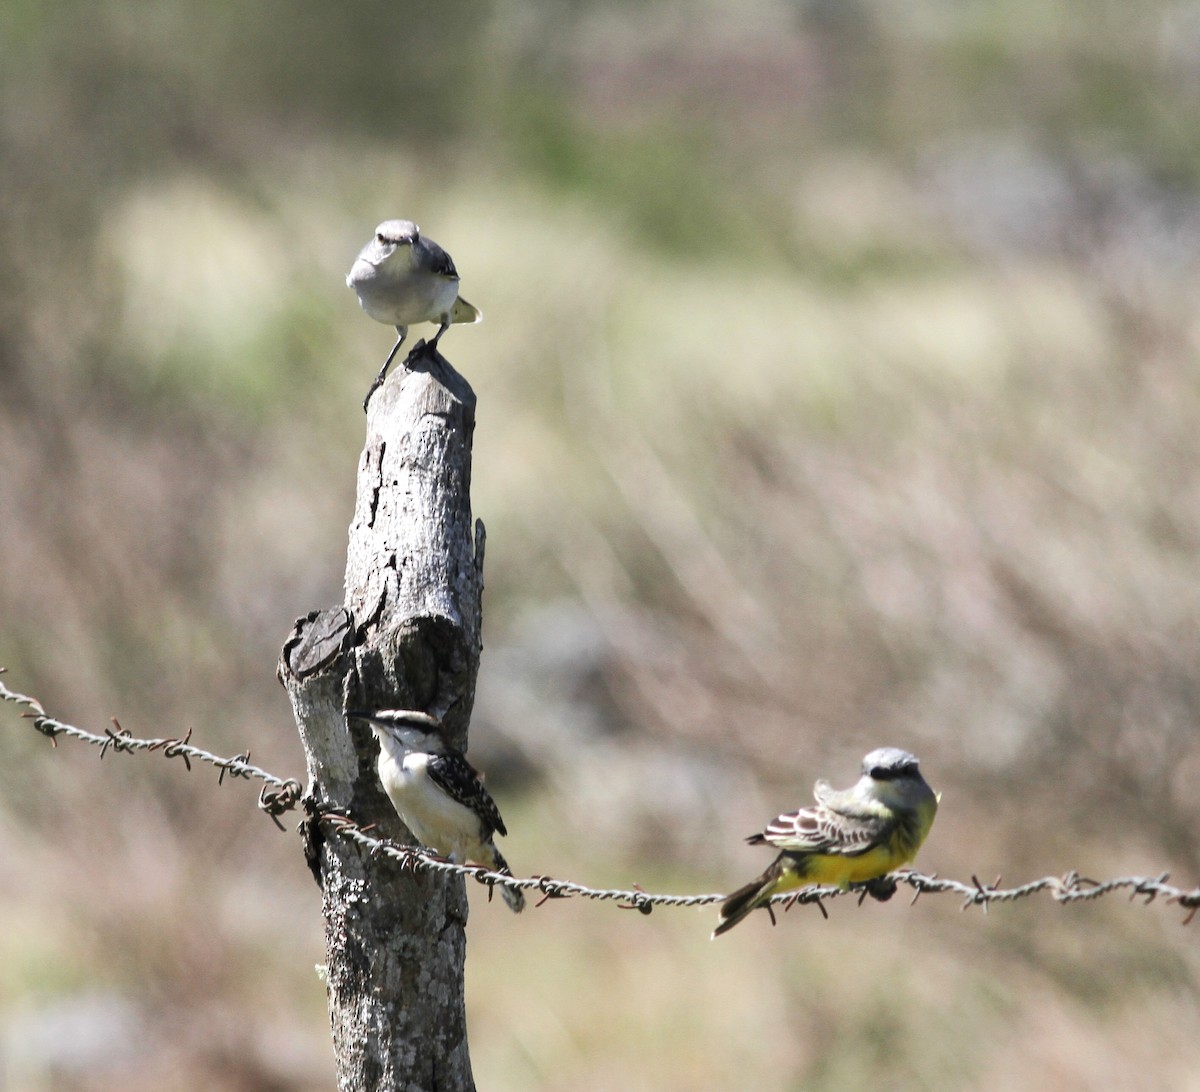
[{"left": 280, "top": 346, "right": 484, "bottom": 1092}]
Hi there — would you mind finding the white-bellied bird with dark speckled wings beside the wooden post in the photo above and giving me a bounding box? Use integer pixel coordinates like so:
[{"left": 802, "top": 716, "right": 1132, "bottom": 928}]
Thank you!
[{"left": 346, "top": 709, "right": 524, "bottom": 913}]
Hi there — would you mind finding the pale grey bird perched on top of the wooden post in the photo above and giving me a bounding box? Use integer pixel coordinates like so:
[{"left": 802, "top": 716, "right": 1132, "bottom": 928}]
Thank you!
[{"left": 346, "top": 220, "right": 484, "bottom": 409}]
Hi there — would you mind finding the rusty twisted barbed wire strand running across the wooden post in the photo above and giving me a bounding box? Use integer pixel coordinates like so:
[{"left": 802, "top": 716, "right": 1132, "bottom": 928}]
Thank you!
[{"left": 0, "top": 667, "right": 1200, "bottom": 925}]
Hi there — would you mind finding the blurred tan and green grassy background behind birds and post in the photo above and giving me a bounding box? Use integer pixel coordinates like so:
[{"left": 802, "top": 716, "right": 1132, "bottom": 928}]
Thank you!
[{"left": 0, "top": 0, "right": 1200, "bottom": 1092}]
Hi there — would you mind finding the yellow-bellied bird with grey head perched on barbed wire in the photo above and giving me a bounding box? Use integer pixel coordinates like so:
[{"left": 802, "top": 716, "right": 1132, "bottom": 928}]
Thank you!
[{"left": 713, "top": 746, "right": 941, "bottom": 940}]
